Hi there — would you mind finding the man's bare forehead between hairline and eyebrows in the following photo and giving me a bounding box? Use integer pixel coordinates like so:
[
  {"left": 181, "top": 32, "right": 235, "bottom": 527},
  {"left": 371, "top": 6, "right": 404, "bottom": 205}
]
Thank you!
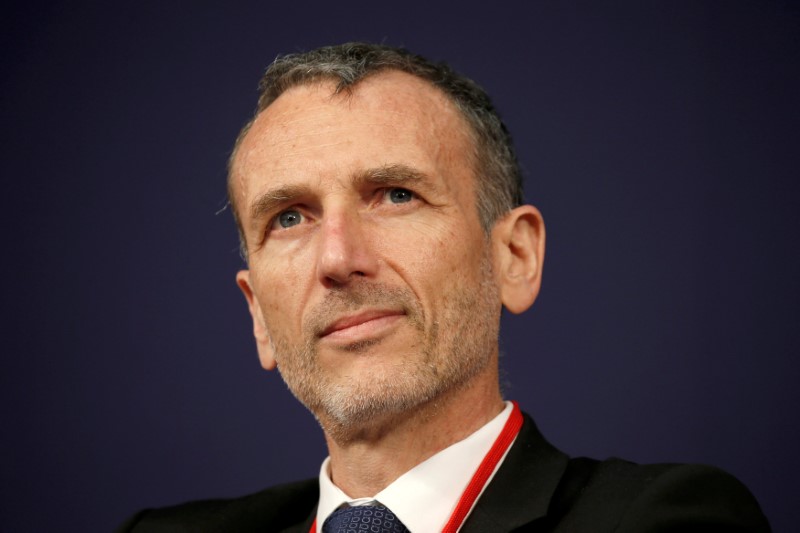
[{"left": 231, "top": 71, "right": 473, "bottom": 206}]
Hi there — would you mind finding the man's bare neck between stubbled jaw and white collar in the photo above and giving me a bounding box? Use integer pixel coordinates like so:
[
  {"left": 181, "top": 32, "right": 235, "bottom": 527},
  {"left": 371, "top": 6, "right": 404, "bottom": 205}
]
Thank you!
[{"left": 318, "top": 369, "right": 503, "bottom": 498}]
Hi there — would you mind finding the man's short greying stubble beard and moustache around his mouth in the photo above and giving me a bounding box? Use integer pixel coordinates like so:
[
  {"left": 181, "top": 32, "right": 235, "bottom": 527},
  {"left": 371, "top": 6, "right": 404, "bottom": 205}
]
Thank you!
[{"left": 272, "top": 246, "right": 500, "bottom": 442}]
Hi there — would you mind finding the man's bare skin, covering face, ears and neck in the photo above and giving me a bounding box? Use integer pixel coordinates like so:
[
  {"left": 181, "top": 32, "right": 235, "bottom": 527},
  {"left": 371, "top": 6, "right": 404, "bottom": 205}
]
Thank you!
[{"left": 231, "top": 71, "right": 544, "bottom": 498}]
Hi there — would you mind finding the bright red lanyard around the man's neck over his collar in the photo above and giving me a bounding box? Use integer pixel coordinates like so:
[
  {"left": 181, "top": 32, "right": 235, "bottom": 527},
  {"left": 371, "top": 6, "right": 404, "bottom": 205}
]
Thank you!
[{"left": 309, "top": 401, "right": 522, "bottom": 533}]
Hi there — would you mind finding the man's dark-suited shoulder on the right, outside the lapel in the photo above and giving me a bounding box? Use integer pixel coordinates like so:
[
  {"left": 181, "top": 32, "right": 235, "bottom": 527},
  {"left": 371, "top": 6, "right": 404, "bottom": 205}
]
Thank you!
[{"left": 551, "top": 458, "right": 770, "bottom": 533}]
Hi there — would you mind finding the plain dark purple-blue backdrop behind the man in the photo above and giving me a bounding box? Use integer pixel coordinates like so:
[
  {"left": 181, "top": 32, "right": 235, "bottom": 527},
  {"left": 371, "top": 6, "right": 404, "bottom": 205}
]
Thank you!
[{"left": 0, "top": 0, "right": 800, "bottom": 532}]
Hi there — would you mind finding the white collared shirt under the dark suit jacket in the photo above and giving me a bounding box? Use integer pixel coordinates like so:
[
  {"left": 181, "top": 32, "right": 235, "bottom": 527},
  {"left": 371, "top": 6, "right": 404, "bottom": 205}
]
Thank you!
[{"left": 317, "top": 402, "right": 513, "bottom": 533}]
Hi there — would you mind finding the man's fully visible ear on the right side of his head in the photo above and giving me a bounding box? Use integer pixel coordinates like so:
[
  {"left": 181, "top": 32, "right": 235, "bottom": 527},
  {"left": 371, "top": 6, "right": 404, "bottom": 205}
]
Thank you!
[{"left": 492, "top": 205, "right": 544, "bottom": 314}]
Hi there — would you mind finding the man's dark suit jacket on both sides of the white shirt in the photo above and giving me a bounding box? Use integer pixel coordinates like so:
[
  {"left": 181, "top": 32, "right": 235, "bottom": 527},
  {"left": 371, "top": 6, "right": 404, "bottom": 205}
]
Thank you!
[{"left": 117, "top": 415, "right": 770, "bottom": 533}]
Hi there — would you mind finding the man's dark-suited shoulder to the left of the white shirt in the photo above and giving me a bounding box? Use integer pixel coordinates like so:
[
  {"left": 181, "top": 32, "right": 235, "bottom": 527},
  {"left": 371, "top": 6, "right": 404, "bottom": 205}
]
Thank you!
[{"left": 116, "top": 479, "right": 319, "bottom": 533}]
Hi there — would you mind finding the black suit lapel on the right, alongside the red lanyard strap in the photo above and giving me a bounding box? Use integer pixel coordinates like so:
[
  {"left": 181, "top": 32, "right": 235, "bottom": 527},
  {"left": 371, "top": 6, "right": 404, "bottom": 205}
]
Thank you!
[{"left": 461, "top": 413, "right": 568, "bottom": 533}]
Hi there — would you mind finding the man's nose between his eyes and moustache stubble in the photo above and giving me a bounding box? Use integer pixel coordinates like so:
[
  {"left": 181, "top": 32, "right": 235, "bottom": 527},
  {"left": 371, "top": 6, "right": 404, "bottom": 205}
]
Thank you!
[{"left": 317, "top": 211, "right": 378, "bottom": 287}]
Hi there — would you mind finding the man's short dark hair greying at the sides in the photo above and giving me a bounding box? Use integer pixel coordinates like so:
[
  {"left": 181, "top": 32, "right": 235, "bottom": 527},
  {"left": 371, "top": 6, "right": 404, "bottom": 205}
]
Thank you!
[{"left": 228, "top": 43, "right": 524, "bottom": 258}]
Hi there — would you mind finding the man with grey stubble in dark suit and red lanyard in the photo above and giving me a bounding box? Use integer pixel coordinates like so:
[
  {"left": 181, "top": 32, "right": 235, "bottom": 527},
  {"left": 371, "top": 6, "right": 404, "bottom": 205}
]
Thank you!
[{"left": 120, "top": 44, "right": 769, "bottom": 532}]
